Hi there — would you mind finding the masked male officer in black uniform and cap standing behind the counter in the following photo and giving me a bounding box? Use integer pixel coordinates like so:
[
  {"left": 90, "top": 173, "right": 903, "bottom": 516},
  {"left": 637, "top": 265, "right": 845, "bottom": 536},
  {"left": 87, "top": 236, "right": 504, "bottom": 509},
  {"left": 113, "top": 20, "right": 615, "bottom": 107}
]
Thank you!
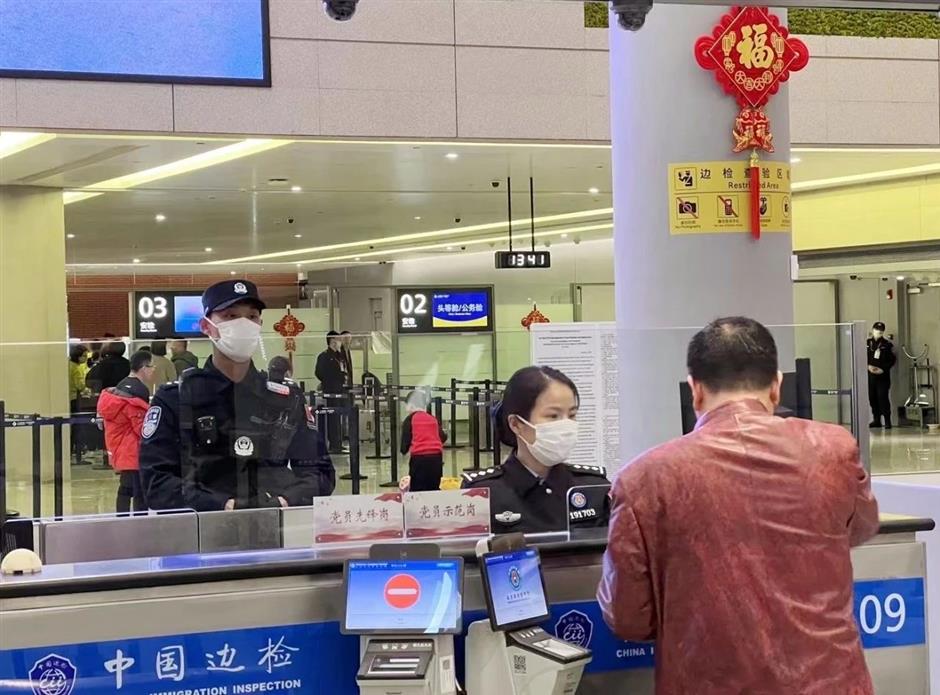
[{"left": 140, "top": 280, "right": 336, "bottom": 511}]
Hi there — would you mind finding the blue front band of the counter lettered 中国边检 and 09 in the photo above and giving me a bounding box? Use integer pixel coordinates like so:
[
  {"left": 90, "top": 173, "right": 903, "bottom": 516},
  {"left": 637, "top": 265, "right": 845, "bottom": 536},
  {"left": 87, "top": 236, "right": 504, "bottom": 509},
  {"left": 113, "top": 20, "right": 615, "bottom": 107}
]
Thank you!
[{"left": 0, "top": 578, "right": 926, "bottom": 695}]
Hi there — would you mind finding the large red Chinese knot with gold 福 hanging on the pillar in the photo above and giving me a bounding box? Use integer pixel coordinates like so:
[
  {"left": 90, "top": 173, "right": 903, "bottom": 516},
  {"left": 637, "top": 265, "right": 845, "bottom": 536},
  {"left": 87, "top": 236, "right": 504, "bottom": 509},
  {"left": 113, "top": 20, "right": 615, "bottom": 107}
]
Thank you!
[{"left": 695, "top": 5, "right": 809, "bottom": 239}]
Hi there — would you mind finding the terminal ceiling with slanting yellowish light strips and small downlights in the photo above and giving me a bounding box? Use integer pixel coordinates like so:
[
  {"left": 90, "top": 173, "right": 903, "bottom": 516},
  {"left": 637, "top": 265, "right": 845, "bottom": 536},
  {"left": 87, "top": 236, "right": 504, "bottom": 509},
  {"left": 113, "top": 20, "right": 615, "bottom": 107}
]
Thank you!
[{"left": 0, "top": 131, "right": 940, "bottom": 274}]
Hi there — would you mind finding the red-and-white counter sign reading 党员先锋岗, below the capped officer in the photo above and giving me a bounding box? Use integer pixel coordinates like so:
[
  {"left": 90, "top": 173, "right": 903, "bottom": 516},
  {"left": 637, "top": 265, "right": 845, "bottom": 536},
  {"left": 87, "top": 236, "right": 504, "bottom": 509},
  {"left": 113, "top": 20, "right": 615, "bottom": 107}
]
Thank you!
[{"left": 313, "top": 492, "right": 405, "bottom": 545}]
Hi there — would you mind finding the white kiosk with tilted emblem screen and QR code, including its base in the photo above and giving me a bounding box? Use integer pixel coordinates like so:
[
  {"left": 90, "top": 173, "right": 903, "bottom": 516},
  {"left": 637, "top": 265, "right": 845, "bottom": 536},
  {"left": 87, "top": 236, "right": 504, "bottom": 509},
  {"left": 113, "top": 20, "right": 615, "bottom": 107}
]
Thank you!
[{"left": 466, "top": 546, "right": 591, "bottom": 695}]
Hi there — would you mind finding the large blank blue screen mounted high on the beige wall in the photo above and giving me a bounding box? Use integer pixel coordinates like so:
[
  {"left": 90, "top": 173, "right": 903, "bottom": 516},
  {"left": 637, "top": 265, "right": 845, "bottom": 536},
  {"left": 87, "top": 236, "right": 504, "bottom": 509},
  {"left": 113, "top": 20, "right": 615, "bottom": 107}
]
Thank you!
[{"left": 0, "top": 0, "right": 270, "bottom": 86}]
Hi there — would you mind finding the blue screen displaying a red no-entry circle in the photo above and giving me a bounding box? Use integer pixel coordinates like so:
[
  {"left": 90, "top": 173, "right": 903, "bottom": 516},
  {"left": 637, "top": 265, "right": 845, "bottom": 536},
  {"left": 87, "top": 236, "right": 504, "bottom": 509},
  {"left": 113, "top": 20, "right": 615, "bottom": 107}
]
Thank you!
[{"left": 343, "top": 558, "right": 463, "bottom": 635}]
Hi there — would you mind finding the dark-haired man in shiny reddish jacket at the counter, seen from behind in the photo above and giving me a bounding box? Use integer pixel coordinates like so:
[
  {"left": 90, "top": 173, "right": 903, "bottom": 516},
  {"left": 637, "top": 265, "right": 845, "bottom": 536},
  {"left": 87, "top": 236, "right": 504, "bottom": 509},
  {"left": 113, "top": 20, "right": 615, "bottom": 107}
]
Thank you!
[{"left": 597, "top": 317, "right": 878, "bottom": 695}]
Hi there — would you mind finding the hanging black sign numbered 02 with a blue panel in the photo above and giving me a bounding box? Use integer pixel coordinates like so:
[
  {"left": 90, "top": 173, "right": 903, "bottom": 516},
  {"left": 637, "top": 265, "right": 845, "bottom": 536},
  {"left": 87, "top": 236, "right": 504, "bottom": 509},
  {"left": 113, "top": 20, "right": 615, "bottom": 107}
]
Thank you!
[{"left": 398, "top": 287, "right": 493, "bottom": 334}]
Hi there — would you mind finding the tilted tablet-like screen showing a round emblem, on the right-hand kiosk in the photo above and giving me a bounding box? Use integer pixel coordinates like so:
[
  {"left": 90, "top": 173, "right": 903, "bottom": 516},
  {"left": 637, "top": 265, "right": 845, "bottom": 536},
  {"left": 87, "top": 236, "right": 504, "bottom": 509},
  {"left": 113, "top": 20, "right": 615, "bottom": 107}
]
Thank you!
[{"left": 483, "top": 548, "right": 548, "bottom": 628}]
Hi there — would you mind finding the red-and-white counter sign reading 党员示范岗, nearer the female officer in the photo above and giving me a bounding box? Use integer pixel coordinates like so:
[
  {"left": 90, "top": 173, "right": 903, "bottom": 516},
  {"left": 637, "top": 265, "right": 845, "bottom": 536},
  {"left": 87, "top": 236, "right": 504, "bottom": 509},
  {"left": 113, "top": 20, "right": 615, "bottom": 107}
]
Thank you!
[{"left": 404, "top": 488, "right": 490, "bottom": 539}]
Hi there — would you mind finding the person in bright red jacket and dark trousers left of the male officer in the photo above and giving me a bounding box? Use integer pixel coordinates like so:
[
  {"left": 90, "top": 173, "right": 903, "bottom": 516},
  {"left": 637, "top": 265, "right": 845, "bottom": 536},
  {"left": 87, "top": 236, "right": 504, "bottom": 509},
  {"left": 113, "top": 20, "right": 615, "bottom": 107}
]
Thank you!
[{"left": 98, "top": 351, "right": 153, "bottom": 514}]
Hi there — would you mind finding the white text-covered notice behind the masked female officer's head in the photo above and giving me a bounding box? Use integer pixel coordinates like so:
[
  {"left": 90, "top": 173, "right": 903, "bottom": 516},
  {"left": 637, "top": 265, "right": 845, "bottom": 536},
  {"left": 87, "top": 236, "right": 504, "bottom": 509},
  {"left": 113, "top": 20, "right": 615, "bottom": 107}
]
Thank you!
[{"left": 530, "top": 322, "right": 621, "bottom": 477}]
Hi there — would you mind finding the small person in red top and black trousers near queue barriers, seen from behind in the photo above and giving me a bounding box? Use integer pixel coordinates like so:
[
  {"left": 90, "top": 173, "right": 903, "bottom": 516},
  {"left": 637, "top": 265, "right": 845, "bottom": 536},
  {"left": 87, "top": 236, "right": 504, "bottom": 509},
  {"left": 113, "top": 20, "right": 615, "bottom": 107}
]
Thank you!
[{"left": 401, "top": 391, "right": 447, "bottom": 492}]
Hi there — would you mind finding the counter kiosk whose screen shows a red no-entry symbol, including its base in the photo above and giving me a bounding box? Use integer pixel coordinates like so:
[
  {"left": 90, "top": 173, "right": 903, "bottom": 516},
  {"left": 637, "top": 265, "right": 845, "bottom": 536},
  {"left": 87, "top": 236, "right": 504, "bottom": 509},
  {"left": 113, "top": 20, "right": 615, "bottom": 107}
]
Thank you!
[{"left": 341, "top": 552, "right": 463, "bottom": 695}]
